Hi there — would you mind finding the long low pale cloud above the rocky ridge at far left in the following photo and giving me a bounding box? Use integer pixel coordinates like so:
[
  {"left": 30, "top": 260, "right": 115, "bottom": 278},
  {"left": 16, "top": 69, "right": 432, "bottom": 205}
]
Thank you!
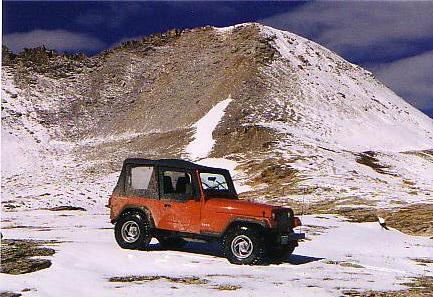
[{"left": 3, "top": 30, "right": 105, "bottom": 52}]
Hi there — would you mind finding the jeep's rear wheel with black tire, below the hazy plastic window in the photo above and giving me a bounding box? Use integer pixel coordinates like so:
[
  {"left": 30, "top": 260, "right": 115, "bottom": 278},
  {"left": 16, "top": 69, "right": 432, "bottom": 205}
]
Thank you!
[{"left": 114, "top": 212, "right": 152, "bottom": 250}]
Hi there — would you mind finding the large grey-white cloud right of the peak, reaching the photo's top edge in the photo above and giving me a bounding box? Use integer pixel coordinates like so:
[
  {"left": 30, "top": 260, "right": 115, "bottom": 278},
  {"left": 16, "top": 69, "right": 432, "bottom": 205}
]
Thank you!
[{"left": 261, "top": 2, "right": 433, "bottom": 58}]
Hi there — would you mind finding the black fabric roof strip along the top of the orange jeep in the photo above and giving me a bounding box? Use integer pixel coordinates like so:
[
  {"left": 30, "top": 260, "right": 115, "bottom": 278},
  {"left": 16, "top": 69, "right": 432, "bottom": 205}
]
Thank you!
[{"left": 123, "top": 158, "right": 228, "bottom": 173}]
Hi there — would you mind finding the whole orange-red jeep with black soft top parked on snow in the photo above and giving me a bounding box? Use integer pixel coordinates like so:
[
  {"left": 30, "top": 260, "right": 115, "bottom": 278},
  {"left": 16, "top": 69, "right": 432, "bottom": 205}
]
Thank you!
[{"left": 108, "top": 159, "right": 305, "bottom": 265}]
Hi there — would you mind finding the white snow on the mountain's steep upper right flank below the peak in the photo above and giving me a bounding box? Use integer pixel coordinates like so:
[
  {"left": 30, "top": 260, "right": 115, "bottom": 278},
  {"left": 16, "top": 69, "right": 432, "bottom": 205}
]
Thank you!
[{"left": 258, "top": 26, "right": 433, "bottom": 152}]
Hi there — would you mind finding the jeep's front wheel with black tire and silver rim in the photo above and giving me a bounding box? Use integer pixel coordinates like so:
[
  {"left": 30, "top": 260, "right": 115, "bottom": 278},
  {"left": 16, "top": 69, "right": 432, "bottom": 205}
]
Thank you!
[{"left": 222, "top": 226, "right": 266, "bottom": 265}]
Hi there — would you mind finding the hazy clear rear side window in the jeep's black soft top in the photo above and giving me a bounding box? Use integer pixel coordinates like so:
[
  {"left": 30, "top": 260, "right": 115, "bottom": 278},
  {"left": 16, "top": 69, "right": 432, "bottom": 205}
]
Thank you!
[{"left": 126, "top": 166, "right": 158, "bottom": 198}]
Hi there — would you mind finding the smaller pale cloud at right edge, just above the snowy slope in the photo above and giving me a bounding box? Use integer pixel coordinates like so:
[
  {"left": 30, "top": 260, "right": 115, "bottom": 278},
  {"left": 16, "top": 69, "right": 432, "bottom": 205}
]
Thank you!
[{"left": 372, "top": 51, "right": 433, "bottom": 109}]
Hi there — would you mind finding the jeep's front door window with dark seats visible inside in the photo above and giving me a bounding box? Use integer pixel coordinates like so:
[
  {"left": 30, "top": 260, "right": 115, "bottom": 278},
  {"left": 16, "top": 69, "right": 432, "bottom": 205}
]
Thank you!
[{"left": 161, "top": 170, "right": 195, "bottom": 201}]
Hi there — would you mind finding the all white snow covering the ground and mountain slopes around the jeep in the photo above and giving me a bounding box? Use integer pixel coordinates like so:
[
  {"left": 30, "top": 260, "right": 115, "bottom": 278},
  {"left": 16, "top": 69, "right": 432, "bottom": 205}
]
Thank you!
[{"left": 0, "top": 25, "right": 433, "bottom": 296}]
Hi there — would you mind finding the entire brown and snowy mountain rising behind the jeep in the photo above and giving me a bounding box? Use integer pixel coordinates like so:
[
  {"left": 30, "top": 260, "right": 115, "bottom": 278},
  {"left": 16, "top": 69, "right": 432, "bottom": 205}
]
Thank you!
[{"left": 2, "top": 24, "right": 433, "bottom": 213}]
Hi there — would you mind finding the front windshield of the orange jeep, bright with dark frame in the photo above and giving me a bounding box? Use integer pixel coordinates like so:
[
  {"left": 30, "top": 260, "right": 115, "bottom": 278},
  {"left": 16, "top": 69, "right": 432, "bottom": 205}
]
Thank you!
[{"left": 200, "top": 172, "right": 236, "bottom": 198}]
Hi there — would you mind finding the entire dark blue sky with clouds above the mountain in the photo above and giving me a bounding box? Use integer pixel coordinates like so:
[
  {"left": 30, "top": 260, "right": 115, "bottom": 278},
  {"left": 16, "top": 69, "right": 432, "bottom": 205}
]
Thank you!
[{"left": 2, "top": 1, "right": 433, "bottom": 117}]
